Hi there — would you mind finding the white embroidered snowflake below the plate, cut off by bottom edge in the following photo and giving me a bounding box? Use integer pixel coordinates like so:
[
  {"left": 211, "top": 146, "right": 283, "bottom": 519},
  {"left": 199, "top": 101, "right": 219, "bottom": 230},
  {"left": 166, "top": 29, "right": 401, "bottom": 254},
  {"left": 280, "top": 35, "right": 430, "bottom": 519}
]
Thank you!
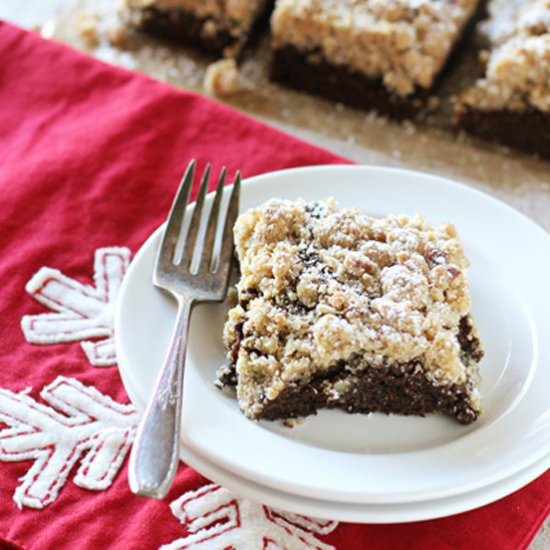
[{"left": 161, "top": 484, "right": 338, "bottom": 550}]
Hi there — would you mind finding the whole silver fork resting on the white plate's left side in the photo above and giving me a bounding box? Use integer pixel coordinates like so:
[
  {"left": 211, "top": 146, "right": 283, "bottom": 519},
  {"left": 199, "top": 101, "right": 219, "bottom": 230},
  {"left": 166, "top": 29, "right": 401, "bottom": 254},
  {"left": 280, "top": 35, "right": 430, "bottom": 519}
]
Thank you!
[{"left": 129, "top": 161, "right": 241, "bottom": 498}]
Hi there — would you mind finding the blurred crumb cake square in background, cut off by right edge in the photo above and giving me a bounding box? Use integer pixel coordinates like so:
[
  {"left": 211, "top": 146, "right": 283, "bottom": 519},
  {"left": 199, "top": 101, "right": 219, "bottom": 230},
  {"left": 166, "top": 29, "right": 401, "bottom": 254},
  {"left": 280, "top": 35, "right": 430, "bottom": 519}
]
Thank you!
[{"left": 455, "top": 0, "right": 550, "bottom": 158}]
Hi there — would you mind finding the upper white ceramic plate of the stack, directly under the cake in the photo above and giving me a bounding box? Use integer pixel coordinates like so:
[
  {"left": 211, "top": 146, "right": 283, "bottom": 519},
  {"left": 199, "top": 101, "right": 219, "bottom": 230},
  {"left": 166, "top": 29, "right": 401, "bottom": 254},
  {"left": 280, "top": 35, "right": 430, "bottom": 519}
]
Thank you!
[{"left": 115, "top": 166, "right": 550, "bottom": 503}]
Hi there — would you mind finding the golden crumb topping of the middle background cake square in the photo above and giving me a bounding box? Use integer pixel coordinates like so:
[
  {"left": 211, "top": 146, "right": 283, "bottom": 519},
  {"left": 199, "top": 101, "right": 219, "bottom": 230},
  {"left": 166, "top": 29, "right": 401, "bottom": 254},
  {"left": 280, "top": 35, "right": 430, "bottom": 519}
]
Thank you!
[{"left": 272, "top": 0, "right": 478, "bottom": 96}]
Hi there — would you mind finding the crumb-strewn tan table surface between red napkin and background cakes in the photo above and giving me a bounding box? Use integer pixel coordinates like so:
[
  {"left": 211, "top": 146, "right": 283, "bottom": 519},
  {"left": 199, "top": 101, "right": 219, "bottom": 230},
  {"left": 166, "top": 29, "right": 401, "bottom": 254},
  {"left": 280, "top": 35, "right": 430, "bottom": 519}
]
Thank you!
[{"left": 0, "top": 0, "right": 550, "bottom": 550}]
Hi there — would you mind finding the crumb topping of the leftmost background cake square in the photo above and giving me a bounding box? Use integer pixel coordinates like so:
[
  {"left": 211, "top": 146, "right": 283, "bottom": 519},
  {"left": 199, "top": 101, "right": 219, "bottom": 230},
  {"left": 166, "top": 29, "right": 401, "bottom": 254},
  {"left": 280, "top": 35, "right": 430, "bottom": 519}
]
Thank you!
[{"left": 124, "top": 0, "right": 268, "bottom": 38}]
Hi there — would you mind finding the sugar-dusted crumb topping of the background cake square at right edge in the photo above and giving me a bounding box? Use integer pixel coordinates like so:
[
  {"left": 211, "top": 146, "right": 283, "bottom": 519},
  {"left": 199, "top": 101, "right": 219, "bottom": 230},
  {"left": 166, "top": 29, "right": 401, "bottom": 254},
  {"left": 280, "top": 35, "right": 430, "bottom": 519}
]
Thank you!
[{"left": 458, "top": 0, "right": 550, "bottom": 112}]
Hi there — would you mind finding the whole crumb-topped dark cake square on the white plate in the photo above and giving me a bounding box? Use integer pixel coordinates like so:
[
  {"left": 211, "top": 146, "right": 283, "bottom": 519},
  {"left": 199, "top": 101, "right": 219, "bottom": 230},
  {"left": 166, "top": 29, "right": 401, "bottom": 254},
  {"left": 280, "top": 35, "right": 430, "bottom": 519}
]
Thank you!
[{"left": 218, "top": 199, "right": 483, "bottom": 424}]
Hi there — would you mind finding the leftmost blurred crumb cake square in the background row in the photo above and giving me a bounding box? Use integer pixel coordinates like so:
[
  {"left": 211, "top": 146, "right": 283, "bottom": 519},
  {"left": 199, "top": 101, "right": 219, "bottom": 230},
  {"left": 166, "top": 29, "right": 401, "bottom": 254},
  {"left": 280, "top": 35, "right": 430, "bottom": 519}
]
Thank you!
[{"left": 124, "top": 0, "right": 273, "bottom": 57}]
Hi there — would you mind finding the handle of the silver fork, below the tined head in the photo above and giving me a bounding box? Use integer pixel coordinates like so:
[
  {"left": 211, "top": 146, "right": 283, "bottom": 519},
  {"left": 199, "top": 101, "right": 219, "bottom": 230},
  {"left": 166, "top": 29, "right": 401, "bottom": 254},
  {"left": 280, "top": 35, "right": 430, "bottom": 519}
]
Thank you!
[{"left": 129, "top": 296, "right": 193, "bottom": 499}]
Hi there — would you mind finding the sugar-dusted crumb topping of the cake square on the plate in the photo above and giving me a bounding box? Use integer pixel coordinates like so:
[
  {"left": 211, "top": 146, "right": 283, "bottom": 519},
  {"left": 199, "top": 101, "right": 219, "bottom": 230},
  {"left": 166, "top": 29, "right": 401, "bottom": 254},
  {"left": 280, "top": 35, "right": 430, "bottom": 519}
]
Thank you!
[{"left": 224, "top": 199, "right": 484, "bottom": 417}]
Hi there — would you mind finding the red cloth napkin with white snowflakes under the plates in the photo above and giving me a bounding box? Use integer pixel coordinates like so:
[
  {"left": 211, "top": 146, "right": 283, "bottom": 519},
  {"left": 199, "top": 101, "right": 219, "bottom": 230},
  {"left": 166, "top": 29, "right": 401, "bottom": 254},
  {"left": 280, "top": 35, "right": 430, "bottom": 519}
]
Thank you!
[{"left": 0, "top": 22, "right": 550, "bottom": 550}]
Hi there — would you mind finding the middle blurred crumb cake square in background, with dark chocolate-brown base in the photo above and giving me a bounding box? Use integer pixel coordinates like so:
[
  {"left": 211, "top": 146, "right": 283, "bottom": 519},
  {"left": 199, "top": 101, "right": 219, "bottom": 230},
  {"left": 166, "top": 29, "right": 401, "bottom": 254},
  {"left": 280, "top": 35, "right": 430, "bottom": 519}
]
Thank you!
[{"left": 271, "top": 0, "right": 480, "bottom": 118}]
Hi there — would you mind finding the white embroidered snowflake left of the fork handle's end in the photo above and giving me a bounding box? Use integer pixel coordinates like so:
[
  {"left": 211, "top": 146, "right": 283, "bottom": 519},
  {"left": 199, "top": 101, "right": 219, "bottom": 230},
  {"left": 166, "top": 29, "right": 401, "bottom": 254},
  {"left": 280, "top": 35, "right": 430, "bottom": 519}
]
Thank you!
[{"left": 0, "top": 376, "right": 139, "bottom": 508}]
